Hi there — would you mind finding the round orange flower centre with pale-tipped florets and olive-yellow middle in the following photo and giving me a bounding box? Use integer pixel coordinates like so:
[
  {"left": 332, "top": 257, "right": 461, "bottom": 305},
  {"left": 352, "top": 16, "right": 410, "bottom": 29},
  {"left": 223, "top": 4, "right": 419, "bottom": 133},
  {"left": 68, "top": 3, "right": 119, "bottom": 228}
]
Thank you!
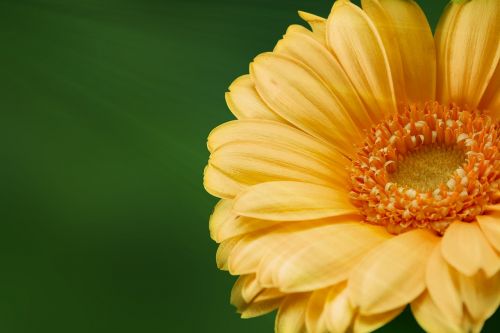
[{"left": 350, "top": 103, "right": 500, "bottom": 234}]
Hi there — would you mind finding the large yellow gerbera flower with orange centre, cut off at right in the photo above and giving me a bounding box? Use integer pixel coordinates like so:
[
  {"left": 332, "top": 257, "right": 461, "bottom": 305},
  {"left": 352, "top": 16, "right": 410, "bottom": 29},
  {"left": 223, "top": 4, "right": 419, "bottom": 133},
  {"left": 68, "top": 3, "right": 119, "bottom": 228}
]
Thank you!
[{"left": 204, "top": 0, "right": 500, "bottom": 333}]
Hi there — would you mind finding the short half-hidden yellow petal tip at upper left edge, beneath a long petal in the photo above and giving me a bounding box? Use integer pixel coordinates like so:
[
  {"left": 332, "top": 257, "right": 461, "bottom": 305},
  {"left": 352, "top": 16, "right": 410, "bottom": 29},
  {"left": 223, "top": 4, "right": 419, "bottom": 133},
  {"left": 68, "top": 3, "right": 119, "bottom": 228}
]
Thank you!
[{"left": 226, "top": 75, "right": 285, "bottom": 122}]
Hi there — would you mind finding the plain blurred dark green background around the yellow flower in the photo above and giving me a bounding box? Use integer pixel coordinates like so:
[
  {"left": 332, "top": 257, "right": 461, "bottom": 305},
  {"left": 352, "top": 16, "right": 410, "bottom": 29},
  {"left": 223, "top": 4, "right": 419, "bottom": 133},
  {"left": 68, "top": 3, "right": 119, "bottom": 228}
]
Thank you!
[{"left": 0, "top": 0, "right": 500, "bottom": 333}]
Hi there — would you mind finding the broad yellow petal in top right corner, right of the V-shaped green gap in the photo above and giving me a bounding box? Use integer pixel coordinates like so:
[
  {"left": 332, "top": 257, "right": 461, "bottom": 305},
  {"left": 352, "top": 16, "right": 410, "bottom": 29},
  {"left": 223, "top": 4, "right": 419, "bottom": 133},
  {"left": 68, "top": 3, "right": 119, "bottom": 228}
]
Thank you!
[{"left": 436, "top": 0, "right": 500, "bottom": 108}]
